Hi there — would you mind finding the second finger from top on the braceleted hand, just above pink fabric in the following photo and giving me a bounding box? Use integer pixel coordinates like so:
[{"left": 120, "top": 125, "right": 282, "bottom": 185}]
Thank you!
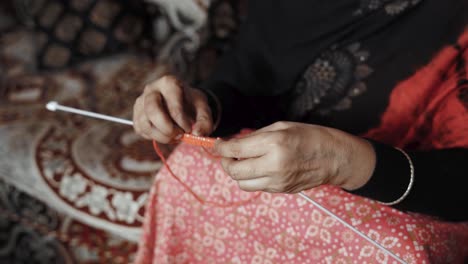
[{"left": 221, "top": 158, "right": 268, "bottom": 181}]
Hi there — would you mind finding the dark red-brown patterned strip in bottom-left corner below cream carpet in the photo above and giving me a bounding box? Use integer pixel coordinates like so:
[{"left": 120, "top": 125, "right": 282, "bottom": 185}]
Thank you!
[{"left": 0, "top": 178, "right": 136, "bottom": 263}]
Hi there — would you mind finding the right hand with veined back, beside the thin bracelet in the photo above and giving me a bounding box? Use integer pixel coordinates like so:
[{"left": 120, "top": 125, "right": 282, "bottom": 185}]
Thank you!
[{"left": 215, "top": 122, "right": 375, "bottom": 193}]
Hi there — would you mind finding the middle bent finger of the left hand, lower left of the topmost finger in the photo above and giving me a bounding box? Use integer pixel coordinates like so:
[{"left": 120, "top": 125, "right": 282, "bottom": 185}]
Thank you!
[{"left": 144, "top": 92, "right": 183, "bottom": 138}]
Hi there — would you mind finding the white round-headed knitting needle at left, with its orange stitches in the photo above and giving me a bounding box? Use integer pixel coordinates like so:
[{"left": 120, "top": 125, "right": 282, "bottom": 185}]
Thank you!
[{"left": 46, "top": 101, "right": 216, "bottom": 148}]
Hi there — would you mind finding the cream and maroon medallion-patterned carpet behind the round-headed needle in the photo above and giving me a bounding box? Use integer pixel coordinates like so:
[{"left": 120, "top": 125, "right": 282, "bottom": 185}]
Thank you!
[{"left": 0, "top": 29, "right": 170, "bottom": 263}]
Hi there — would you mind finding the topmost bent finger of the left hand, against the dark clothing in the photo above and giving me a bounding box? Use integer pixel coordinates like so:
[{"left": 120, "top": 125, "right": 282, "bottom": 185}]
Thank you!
[{"left": 156, "top": 75, "right": 192, "bottom": 133}]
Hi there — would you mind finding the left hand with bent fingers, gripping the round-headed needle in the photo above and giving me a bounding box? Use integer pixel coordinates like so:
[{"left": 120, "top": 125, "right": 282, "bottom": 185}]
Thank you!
[{"left": 133, "top": 76, "right": 213, "bottom": 143}]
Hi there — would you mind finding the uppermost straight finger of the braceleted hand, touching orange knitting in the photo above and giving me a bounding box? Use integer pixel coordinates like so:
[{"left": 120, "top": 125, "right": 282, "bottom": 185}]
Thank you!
[{"left": 215, "top": 134, "right": 268, "bottom": 159}]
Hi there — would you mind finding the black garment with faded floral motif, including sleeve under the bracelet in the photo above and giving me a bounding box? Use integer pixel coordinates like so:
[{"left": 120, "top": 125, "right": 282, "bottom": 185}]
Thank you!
[{"left": 203, "top": 0, "right": 468, "bottom": 221}]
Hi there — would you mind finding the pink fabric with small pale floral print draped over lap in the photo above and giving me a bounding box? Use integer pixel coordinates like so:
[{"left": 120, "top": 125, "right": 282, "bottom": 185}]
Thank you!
[{"left": 136, "top": 145, "right": 468, "bottom": 263}]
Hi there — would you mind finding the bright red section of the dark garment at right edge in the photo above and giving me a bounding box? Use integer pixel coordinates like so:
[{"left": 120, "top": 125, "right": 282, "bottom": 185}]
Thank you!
[{"left": 364, "top": 31, "right": 468, "bottom": 150}]
